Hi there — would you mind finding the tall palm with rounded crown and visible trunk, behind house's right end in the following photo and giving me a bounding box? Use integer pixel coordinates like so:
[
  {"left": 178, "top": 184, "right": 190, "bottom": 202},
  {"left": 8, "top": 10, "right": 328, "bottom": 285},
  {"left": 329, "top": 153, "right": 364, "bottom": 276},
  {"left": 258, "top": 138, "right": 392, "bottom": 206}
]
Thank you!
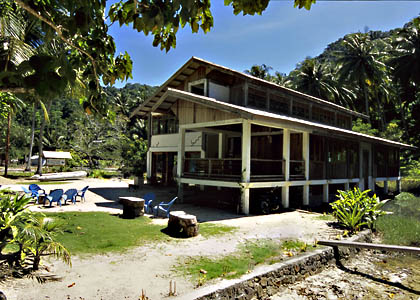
[{"left": 334, "top": 33, "right": 385, "bottom": 116}]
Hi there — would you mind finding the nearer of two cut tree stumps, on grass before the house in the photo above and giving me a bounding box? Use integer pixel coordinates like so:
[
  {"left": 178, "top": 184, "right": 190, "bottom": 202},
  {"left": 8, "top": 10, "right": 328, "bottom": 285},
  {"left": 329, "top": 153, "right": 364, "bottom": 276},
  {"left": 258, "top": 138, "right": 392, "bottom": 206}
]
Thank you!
[{"left": 168, "top": 211, "right": 199, "bottom": 237}]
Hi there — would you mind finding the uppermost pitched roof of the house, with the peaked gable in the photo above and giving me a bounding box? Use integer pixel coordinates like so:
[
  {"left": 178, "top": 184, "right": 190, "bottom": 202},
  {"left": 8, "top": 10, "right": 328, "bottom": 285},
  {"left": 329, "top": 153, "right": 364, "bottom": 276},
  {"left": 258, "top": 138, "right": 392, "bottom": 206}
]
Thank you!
[{"left": 130, "top": 56, "right": 369, "bottom": 119}]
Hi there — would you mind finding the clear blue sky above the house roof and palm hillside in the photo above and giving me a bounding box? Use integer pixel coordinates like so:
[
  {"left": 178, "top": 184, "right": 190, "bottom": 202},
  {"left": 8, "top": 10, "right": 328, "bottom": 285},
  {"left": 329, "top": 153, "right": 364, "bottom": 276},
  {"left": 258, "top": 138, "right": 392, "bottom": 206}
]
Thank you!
[{"left": 109, "top": 0, "right": 420, "bottom": 87}]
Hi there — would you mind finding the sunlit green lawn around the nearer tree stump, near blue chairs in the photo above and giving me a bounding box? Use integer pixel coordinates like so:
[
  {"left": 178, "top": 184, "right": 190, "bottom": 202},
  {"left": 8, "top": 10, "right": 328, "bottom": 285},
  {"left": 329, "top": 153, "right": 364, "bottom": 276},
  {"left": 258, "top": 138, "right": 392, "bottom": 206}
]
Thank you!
[{"left": 46, "top": 212, "right": 234, "bottom": 255}]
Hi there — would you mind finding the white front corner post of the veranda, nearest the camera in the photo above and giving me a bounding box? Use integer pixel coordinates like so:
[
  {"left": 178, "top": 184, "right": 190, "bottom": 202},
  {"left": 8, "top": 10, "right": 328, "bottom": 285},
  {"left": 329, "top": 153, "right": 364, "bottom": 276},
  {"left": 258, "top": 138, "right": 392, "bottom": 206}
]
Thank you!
[{"left": 241, "top": 120, "right": 251, "bottom": 215}]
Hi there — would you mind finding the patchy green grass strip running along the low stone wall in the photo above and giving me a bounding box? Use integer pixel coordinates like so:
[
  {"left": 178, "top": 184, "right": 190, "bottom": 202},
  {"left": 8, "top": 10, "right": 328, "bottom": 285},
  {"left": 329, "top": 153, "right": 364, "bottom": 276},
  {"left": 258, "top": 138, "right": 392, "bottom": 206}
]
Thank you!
[{"left": 177, "top": 240, "right": 311, "bottom": 286}]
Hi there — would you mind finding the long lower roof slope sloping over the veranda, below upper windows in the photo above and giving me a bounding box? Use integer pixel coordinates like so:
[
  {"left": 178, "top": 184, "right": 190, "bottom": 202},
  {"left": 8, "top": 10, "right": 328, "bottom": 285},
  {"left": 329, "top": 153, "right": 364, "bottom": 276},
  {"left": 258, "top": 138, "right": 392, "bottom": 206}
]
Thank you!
[{"left": 166, "top": 88, "right": 417, "bottom": 149}]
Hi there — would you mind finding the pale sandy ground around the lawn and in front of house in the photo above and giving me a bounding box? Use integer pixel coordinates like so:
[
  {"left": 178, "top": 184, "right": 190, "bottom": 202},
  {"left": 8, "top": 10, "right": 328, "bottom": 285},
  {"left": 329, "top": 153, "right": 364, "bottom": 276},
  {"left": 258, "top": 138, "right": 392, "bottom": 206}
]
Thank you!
[{"left": 0, "top": 179, "right": 337, "bottom": 300}]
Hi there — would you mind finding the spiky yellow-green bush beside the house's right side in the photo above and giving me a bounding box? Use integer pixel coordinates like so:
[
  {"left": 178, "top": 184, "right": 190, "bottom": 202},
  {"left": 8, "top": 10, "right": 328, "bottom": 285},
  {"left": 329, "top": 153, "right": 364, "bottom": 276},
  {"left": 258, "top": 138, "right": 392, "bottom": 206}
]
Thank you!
[{"left": 330, "top": 187, "right": 387, "bottom": 232}]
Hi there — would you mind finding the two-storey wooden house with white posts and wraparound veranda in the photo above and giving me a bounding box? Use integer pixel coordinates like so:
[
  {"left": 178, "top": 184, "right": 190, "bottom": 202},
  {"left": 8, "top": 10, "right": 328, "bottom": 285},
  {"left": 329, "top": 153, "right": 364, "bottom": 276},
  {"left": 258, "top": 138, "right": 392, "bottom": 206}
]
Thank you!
[{"left": 133, "top": 57, "right": 412, "bottom": 214}]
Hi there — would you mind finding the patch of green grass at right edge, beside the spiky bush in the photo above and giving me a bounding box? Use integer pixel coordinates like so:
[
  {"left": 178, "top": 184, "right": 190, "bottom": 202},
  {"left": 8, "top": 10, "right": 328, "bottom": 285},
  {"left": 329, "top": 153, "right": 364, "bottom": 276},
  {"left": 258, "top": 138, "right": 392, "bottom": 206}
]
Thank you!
[{"left": 376, "top": 193, "right": 420, "bottom": 246}]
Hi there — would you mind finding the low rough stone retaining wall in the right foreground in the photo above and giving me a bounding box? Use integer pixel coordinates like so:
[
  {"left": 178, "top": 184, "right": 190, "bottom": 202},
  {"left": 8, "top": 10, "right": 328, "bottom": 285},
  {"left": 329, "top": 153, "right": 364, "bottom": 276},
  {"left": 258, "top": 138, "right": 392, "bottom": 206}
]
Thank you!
[{"left": 194, "top": 232, "right": 370, "bottom": 300}]
